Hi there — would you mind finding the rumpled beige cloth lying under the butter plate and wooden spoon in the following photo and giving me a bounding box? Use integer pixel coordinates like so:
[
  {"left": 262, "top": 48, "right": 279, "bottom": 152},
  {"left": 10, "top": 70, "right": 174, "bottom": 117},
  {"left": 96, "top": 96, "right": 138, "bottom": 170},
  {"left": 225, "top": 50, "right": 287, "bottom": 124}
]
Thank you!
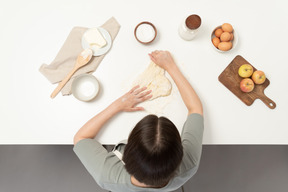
[{"left": 39, "top": 17, "right": 120, "bottom": 95}]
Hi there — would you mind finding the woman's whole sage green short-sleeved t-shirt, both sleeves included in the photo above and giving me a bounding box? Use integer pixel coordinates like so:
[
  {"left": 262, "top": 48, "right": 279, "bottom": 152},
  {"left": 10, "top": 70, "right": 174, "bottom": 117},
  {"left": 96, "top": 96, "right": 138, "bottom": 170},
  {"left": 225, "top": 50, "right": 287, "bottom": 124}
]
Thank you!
[{"left": 73, "top": 113, "right": 204, "bottom": 192}]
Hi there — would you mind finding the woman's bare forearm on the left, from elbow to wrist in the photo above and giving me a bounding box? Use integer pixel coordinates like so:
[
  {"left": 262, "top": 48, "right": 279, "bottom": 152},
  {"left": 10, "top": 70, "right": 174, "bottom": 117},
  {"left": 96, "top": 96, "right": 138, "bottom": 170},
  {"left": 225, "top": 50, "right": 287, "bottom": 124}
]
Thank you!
[{"left": 74, "top": 102, "right": 121, "bottom": 145}]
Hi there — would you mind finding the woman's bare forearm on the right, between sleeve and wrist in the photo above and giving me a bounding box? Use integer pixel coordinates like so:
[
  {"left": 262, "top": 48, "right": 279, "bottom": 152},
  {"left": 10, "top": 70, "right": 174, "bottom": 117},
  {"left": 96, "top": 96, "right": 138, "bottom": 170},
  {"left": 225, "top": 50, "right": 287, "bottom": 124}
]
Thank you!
[{"left": 167, "top": 64, "right": 203, "bottom": 115}]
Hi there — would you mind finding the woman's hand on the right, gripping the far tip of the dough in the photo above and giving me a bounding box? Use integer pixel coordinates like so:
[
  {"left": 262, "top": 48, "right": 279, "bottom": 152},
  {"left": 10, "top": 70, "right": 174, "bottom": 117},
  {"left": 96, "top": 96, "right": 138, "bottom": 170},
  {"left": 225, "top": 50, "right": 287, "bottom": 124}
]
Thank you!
[{"left": 149, "top": 50, "right": 176, "bottom": 73}]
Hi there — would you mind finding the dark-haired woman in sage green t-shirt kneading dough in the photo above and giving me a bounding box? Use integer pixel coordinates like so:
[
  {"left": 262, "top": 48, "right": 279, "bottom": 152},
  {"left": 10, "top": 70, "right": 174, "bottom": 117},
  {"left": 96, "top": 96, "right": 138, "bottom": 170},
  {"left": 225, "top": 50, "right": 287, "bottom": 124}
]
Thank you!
[{"left": 74, "top": 51, "right": 204, "bottom": 192}]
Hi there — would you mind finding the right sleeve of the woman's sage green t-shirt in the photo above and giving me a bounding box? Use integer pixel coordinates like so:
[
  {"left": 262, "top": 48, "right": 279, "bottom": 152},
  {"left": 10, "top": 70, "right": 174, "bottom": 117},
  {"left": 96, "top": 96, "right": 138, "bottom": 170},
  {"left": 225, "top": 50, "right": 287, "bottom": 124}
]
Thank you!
[{"left": 181, "top": 113, "right": 204, "bottom": 167}]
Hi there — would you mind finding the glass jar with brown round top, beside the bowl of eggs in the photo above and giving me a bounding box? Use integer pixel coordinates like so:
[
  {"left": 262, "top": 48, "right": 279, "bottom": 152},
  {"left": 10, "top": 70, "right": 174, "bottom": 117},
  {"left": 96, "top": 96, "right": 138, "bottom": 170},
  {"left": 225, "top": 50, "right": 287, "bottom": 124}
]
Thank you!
[{"left": 178, "top": 15, "right": 201, "bottom": 41}]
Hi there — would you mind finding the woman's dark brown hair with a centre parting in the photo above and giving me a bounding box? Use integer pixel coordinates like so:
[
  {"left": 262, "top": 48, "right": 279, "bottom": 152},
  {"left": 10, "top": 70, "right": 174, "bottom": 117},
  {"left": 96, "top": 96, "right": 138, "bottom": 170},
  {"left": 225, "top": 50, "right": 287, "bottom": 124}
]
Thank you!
[{"left": 123, "top": 115, "right": 183, "bottom": 187}]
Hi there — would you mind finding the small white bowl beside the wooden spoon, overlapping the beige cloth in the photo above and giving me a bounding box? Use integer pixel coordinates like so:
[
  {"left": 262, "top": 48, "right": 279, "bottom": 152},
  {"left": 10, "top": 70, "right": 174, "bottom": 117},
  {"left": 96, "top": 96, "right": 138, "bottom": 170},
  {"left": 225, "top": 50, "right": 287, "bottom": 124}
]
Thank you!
[{"left": 72, "top": 74, "right": 99, "bottom": 101}]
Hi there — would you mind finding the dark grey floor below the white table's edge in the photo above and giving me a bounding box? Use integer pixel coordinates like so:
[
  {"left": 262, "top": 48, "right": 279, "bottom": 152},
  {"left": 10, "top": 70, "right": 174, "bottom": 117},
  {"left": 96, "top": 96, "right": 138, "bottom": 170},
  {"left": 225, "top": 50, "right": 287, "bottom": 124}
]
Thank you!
[{"left": 0, "top": 145, "right": 288, "bottom": 192}]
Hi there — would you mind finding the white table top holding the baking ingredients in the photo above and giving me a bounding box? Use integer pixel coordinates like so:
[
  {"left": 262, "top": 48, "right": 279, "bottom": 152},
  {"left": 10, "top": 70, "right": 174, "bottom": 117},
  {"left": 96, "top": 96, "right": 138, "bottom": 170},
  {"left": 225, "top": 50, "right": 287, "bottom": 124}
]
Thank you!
[{"left": 0, "top": 0, "right": 288, "bottom": 144}]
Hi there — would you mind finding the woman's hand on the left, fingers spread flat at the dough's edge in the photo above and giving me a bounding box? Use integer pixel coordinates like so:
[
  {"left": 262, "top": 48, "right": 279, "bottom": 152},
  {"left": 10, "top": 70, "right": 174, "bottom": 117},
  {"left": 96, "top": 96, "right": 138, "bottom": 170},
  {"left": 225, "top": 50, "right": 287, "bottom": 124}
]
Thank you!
[{"left": 115, "top": 85, "right": 152, "bottom": 111}]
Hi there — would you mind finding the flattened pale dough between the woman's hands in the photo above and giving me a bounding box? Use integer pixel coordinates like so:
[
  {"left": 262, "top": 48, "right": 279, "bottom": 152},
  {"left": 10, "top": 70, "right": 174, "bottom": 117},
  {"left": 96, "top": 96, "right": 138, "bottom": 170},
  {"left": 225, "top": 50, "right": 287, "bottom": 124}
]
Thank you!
[{"left": 133, "top": 61, "right": 172, "bottom": 100}]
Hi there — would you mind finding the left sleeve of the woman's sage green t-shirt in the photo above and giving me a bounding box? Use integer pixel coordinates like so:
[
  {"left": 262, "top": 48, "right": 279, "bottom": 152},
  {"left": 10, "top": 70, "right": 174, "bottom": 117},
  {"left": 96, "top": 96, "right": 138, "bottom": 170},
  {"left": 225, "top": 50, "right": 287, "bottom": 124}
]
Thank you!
[{"left": 73, "top": 139, "right": 108, "bottom": 183}]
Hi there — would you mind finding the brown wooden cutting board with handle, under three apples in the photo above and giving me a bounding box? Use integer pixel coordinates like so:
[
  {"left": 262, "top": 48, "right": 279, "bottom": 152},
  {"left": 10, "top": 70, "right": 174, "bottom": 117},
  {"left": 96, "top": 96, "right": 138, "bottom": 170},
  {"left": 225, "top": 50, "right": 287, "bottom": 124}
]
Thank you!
[{"left": 218, "top": 55, "right": 276, "bottom": 109}]
